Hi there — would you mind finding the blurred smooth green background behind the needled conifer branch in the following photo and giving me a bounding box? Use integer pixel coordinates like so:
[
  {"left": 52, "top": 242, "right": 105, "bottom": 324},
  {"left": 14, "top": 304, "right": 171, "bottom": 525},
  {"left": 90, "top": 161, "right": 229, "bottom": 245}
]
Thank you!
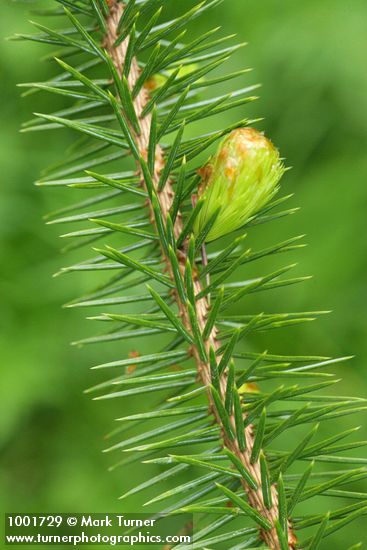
[{"left": 0, "top": 0, "right": 367, "bottom": 550}]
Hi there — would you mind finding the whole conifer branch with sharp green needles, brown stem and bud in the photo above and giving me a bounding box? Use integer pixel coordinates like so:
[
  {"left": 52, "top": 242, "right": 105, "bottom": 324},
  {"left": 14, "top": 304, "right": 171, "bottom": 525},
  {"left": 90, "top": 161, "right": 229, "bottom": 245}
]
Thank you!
[{"left": 15, "top": 0, "right": 367, "bottom": 550}]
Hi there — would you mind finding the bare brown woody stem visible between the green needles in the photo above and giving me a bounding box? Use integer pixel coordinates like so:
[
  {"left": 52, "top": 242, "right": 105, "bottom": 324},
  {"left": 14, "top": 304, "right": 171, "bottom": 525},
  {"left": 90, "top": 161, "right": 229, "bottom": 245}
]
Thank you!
[{"left": 104, "top": 0, "right": 297, "bottom": 550}]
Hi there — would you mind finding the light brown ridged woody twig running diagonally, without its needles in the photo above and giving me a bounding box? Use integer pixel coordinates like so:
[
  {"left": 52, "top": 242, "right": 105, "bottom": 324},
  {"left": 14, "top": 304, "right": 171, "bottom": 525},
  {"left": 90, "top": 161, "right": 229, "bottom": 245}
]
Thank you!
[{"left": 105, "top": 0, "right": 297, "bottom": 550}]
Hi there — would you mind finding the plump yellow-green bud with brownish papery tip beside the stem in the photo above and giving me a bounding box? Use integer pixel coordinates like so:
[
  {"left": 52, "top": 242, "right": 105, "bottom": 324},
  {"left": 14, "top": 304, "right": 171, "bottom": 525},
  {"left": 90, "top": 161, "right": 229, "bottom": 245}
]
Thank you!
[{"left": 194, "top": 128, "right": 284, "bottom": 242}]
